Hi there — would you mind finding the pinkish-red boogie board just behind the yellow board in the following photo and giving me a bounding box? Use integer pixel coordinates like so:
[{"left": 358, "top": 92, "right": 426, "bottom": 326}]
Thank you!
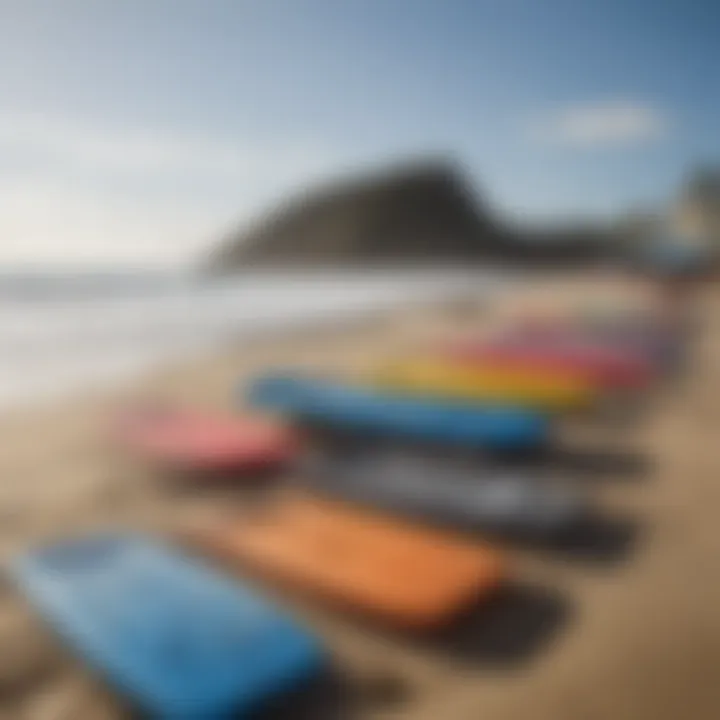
[{"left": 444, "top": 332, "right": 655, "bottom": 389}]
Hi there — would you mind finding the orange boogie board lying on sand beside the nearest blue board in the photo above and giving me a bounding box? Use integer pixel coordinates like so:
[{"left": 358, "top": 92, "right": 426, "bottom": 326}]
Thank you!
[{"left": 192, "top": 496, "right": 506, "bottom": 629}]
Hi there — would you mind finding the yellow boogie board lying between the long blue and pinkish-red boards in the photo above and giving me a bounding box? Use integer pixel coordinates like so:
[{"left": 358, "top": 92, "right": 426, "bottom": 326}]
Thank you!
[{"left": 367, "top": 359, "right": 598, "bottom": 410}]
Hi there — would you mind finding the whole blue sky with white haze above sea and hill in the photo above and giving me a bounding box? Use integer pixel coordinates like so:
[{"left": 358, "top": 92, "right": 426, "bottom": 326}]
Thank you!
[{"left": 0, "top": 0, "right": 720, "bottom": 266}]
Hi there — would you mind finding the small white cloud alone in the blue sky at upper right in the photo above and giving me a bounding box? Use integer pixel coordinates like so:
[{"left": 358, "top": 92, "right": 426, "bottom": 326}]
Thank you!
[{"left": 532, "top": 101, "right": 668, "bottom": 148}]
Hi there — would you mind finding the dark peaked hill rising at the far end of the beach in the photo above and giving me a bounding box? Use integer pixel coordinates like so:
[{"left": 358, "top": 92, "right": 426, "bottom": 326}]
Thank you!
[{"left": 206, "top": 161, "right": 612, "bottom": 273}]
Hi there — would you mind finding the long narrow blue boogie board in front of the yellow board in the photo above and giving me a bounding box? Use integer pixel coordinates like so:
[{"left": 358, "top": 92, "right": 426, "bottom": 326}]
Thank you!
[{"left": 245, "top": 375, "right": 551, "bottom": 450}]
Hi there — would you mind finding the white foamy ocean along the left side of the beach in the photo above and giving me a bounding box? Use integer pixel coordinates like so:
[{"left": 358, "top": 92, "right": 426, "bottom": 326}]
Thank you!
[{"left": 0, "top": 271, "right": 501, "bottom": 409}]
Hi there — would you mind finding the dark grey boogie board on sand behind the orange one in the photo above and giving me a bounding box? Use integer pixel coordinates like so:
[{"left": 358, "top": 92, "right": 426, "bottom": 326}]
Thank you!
[{"left": 299, "top": 450, "right": 588, "bottom": 539}]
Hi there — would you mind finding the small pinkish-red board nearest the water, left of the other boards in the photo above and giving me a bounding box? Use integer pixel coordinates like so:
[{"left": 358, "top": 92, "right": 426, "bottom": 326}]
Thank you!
[{"left": 116, "top": 408, "right": 295, "bottom": 472}]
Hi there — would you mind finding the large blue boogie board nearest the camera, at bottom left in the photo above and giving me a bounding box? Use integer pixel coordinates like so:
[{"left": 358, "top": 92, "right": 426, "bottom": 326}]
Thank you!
[{"left": 11, "top": 534, "right": 324, "bottom": 720}]
